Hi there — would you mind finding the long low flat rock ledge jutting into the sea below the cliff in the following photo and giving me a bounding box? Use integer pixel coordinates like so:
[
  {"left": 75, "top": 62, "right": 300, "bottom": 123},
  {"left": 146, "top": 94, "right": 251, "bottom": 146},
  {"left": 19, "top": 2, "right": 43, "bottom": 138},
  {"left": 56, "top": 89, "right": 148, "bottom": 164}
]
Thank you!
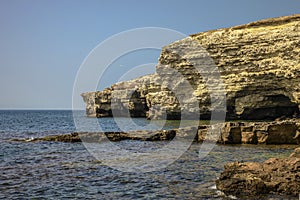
[{"left": 13, "top": 119, "right": 300, "bottom": 144}]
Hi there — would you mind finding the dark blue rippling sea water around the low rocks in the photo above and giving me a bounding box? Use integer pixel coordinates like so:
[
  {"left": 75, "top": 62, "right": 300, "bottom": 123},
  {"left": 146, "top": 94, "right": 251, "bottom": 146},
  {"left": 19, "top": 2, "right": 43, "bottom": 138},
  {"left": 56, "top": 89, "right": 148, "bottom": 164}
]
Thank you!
[{"left": 0, "top": 110, "right": 297, "bottom": 199}]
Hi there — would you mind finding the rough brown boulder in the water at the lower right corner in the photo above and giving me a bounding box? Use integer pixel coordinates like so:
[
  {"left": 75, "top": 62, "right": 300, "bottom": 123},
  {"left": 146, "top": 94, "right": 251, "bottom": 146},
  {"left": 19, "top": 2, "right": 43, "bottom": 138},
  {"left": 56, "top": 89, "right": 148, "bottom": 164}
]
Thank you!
[{"left": 216, "top": 147, "right": 300, "bottom": 198}]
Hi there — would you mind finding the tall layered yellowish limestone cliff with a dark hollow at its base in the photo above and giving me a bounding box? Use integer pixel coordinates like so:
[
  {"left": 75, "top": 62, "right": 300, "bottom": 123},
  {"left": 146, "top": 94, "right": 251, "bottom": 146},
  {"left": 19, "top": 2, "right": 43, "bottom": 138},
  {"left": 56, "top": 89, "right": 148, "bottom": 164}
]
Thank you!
[{"left": 82, "top": 15, "right": 300, "bottom": 119}]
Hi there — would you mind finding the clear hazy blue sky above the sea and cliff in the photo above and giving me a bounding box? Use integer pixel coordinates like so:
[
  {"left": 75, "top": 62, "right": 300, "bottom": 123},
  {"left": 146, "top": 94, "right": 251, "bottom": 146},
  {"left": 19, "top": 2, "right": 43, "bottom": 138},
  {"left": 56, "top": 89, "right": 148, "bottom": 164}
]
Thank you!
[{"left": 0, "top": 0, "right": 300, "bottom": 109}]
